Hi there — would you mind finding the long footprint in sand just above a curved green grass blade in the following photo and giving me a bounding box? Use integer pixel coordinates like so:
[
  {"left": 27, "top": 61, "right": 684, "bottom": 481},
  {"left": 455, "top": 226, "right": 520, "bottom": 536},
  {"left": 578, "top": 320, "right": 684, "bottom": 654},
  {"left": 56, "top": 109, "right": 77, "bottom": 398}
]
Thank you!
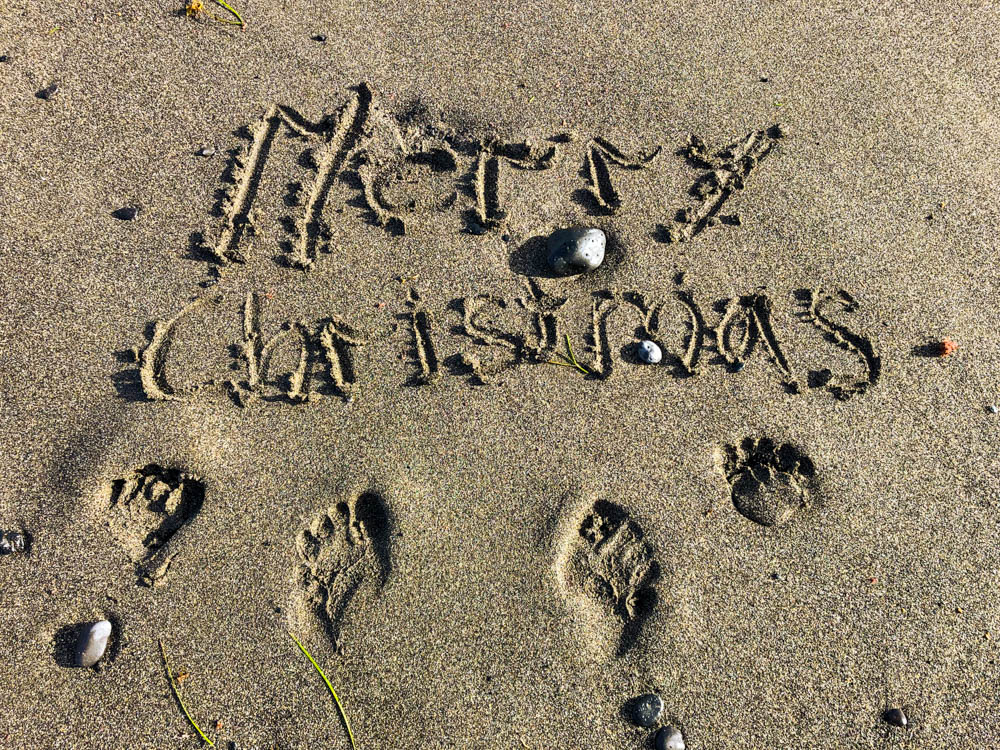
[{"left": 291, "top": 492, "right": 392, "bottom": 651}]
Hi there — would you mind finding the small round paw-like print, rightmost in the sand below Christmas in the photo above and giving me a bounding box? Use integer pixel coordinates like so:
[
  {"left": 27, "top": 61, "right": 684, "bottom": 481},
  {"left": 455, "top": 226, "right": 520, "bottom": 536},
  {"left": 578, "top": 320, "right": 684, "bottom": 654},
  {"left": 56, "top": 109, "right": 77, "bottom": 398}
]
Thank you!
[{"left": 721, "top": 437, "right": 816, "bottom": 526}]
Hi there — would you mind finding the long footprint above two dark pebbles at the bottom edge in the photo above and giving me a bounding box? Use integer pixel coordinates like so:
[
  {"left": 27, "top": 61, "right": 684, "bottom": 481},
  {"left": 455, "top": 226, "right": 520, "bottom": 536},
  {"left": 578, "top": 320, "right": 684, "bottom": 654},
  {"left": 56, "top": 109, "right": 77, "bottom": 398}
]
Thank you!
[{"left": 556, "top": 500, "right": 660, "bottom": 656}]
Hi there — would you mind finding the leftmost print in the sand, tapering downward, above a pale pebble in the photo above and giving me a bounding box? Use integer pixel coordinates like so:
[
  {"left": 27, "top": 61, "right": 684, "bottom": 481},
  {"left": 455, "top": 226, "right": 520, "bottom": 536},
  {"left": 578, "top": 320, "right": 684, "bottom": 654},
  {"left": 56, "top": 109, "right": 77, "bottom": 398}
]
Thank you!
[{"left": 97, "top": 464, "right": 205, "bottom": 586}]
